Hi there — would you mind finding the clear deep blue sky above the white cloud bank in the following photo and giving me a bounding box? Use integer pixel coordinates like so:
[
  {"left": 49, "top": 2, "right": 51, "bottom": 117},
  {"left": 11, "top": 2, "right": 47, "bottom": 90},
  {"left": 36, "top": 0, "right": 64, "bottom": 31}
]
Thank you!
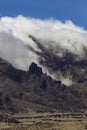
[{"left": 0, "top": 0, "right": 87, "bottom": 29}]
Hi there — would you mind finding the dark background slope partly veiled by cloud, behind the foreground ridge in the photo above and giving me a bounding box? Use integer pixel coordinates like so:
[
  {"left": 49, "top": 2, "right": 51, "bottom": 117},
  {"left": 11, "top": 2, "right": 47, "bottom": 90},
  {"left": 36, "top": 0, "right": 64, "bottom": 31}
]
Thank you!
[{"left": 29, "top": 35, "right": 87, "bottom": 86}]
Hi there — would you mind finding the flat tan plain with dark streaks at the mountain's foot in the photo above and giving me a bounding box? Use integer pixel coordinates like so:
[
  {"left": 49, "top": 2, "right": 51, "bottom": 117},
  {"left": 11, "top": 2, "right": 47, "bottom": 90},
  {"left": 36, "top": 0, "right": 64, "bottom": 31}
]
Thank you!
[{"left": 0, "top": 113, "right": 87, "bottom": 130}]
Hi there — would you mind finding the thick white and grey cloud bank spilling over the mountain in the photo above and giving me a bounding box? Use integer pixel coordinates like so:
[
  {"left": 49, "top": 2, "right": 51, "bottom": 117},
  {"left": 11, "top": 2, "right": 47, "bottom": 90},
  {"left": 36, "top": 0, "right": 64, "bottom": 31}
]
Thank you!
[{"left": 0, "top": 16, "right": 87, "bottom": 84}]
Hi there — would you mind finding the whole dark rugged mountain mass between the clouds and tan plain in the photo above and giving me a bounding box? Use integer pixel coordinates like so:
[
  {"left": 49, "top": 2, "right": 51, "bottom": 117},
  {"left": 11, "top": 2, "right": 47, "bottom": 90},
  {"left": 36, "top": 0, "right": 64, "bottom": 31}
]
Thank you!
[{"left": 0, "top": 55, "right": 87, "bottom": 112}]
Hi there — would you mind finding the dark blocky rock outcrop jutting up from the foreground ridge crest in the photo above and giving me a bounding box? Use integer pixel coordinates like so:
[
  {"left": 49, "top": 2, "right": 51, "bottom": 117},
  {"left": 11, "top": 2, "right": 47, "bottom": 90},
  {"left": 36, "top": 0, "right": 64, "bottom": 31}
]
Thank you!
[{"left": 29, "top": 62, "right": 42, "bottom": 75}]
